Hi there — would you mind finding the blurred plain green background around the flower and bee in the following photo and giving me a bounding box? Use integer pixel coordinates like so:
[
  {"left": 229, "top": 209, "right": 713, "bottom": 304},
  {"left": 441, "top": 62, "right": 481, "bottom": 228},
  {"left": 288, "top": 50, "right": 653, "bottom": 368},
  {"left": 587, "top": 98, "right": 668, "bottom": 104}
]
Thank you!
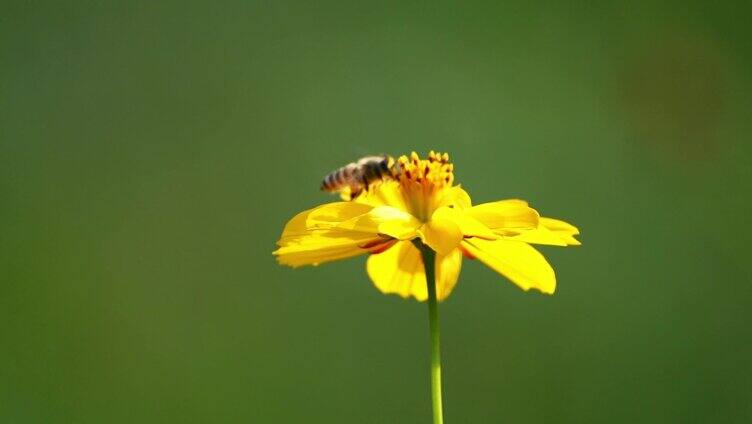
[{"left": 0, "top": 1, "right": 752, "bottom": 423}]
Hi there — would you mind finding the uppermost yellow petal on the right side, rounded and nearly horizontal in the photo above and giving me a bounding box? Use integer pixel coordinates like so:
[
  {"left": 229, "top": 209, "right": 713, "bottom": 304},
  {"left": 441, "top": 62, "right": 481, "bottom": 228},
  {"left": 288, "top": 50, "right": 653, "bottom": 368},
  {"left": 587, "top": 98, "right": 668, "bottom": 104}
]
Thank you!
[{"left": 465, "top": 199, "right": 538, "bottom": 231}]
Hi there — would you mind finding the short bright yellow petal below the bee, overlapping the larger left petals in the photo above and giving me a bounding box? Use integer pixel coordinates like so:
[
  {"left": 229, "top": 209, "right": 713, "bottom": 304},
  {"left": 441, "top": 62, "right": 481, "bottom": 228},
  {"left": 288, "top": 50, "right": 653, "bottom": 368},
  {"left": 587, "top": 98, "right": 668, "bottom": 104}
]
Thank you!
[{"left": 337, "top": 206, "right": 421, "bottom": 240}]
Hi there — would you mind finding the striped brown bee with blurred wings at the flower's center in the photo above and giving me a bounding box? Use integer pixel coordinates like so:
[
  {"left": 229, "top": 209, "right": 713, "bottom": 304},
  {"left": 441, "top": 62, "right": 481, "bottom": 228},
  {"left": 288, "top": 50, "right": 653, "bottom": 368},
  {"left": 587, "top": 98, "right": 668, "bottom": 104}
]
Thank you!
[{"left": 321, "top": 155, "right": 399, "bottom": 200}]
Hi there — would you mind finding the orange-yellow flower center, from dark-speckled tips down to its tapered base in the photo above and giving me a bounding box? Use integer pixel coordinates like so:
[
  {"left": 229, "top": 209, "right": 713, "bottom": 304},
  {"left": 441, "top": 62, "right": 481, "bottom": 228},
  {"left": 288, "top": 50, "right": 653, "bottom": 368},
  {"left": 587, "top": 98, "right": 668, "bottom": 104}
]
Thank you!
[{"left": 395, "top": 150, "right": 454, "bottom": 222}]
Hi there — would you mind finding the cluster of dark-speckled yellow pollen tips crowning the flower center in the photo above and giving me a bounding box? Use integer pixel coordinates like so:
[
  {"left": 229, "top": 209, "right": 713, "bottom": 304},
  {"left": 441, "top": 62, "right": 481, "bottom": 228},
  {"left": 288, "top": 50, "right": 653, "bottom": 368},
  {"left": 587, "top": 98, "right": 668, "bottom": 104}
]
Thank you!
[{"left": 397, "top": 150, "right": 454, "bottom": 189}]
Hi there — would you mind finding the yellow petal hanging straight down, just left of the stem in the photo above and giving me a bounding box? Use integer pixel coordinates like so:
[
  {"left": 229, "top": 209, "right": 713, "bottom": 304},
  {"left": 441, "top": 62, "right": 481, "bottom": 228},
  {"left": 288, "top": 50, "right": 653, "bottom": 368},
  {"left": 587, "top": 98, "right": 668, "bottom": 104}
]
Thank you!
[{"left": 366, "top": 241, "right": 428, "bottom": 301}]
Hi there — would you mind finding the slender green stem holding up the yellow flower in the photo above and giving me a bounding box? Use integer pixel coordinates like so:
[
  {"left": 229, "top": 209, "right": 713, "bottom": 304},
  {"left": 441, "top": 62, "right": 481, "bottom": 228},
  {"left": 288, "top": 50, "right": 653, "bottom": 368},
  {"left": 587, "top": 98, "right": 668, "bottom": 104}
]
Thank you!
[{"left": 420, "top": 245, "right": 444, "bottom": 424}]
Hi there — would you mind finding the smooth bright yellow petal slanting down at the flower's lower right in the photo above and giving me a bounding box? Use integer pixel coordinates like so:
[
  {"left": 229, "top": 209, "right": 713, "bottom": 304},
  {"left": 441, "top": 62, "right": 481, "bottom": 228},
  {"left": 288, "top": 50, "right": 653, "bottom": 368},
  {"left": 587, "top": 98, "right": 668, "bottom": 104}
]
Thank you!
[{"left": 462, "top": 238, "right": 556, "bottom": 294}]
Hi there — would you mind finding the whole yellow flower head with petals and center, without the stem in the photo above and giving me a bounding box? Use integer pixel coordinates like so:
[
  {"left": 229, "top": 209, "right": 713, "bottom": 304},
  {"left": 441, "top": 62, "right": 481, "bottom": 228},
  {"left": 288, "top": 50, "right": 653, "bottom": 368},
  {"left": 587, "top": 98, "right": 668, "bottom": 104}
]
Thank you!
[{"left": 274, "top": 152, "right": 580, "bottom": 301}]
